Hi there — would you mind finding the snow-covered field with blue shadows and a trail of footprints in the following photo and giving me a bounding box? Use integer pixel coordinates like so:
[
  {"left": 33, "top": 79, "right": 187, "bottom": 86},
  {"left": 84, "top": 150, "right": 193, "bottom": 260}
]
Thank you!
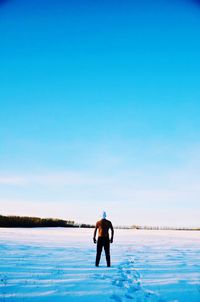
[{"left": 0, "top": 228, "right": 200, "bottom": 302}]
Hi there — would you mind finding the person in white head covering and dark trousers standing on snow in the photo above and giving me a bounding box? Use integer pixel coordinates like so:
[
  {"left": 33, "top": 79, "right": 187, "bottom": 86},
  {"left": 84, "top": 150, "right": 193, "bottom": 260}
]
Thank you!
[{"left": 93, "top": 212, "right": 114, "bottom": 267}]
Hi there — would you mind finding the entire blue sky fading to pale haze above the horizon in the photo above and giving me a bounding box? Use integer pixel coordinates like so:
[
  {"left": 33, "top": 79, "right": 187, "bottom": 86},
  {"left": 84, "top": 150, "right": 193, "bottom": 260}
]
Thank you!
[{"left": 0, "top": 0, "right": 200, "bottom": 226}]
